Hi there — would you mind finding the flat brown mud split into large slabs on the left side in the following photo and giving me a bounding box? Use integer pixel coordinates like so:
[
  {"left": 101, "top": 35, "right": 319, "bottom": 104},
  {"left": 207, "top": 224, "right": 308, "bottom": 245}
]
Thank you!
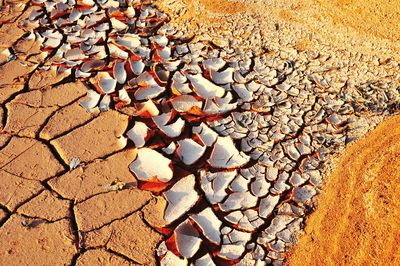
[{"left": 0, "top": 1, "right": 165, "bottom": 265}]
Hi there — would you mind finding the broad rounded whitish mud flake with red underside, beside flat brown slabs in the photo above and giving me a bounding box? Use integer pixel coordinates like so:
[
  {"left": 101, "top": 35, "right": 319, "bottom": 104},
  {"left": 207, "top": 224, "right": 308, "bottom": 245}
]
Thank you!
[{"left": 129, "top": 148, "right": 173, "bottom": 183}]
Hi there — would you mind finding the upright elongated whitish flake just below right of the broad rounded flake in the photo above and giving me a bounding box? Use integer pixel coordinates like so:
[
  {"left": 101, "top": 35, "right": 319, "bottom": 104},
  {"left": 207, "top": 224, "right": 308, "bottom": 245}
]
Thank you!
[{"left": 164, "top": 175, "right": 199, "bottom": 224}]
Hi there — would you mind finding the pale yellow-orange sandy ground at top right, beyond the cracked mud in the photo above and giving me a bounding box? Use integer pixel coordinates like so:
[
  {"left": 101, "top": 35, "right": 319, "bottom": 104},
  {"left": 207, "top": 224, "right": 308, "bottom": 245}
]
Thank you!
[{"left": 156, "top": 0, "right": 400, "bottom": 59}]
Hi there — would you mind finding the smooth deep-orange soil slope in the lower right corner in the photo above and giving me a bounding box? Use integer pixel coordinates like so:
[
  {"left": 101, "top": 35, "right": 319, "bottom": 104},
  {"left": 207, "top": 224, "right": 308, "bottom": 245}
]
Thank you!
[{"left": 289, "top": 116, "right": 400, "bottom": 266}]
